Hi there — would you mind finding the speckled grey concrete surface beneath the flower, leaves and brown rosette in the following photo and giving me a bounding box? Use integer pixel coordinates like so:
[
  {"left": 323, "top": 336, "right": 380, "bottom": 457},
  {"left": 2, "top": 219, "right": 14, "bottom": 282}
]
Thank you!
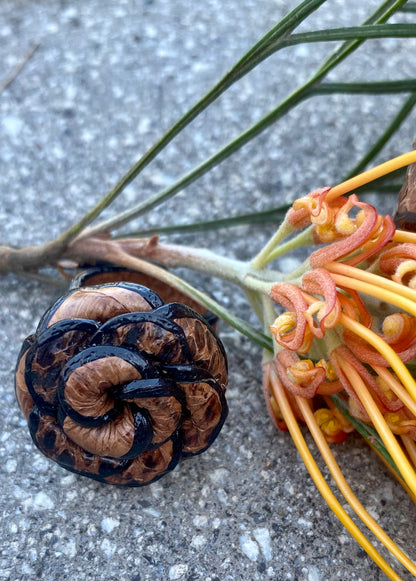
[{"left": 0, "top": 0, "right": 416, "bottom": 581}]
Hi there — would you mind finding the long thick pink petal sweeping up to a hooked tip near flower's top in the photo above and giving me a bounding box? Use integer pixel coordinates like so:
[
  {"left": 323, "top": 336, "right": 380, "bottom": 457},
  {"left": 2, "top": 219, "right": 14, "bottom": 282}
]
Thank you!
[{"left": 309, "top": 196, "right": 378, "bottom": 268}]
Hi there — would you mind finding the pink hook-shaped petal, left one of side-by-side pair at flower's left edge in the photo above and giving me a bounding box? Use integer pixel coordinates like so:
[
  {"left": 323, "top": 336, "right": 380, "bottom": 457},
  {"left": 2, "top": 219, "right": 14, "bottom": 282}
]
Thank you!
[{"left": 270, "top": 282, "right": 308, "bottom": 351}]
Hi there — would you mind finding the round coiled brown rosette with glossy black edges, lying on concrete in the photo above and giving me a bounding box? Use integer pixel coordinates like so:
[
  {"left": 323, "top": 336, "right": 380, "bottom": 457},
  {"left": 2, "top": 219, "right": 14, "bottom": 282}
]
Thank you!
[{"left": 15, "top": 268, "right": 228, "bottom": 486}]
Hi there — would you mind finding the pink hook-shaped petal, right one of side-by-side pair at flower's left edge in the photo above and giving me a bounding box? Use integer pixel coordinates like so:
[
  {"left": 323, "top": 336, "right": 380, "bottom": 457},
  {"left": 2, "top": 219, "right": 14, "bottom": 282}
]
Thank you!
[{"left": 301, "top": 268, "right": 341, "bottom": 333}]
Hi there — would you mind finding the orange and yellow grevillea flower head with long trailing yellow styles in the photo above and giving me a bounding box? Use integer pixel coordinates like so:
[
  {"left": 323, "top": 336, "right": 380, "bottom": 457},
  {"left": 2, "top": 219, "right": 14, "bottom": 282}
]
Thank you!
[{"left": 264, "top": 152, "right": 416, "bottom": 579}]
